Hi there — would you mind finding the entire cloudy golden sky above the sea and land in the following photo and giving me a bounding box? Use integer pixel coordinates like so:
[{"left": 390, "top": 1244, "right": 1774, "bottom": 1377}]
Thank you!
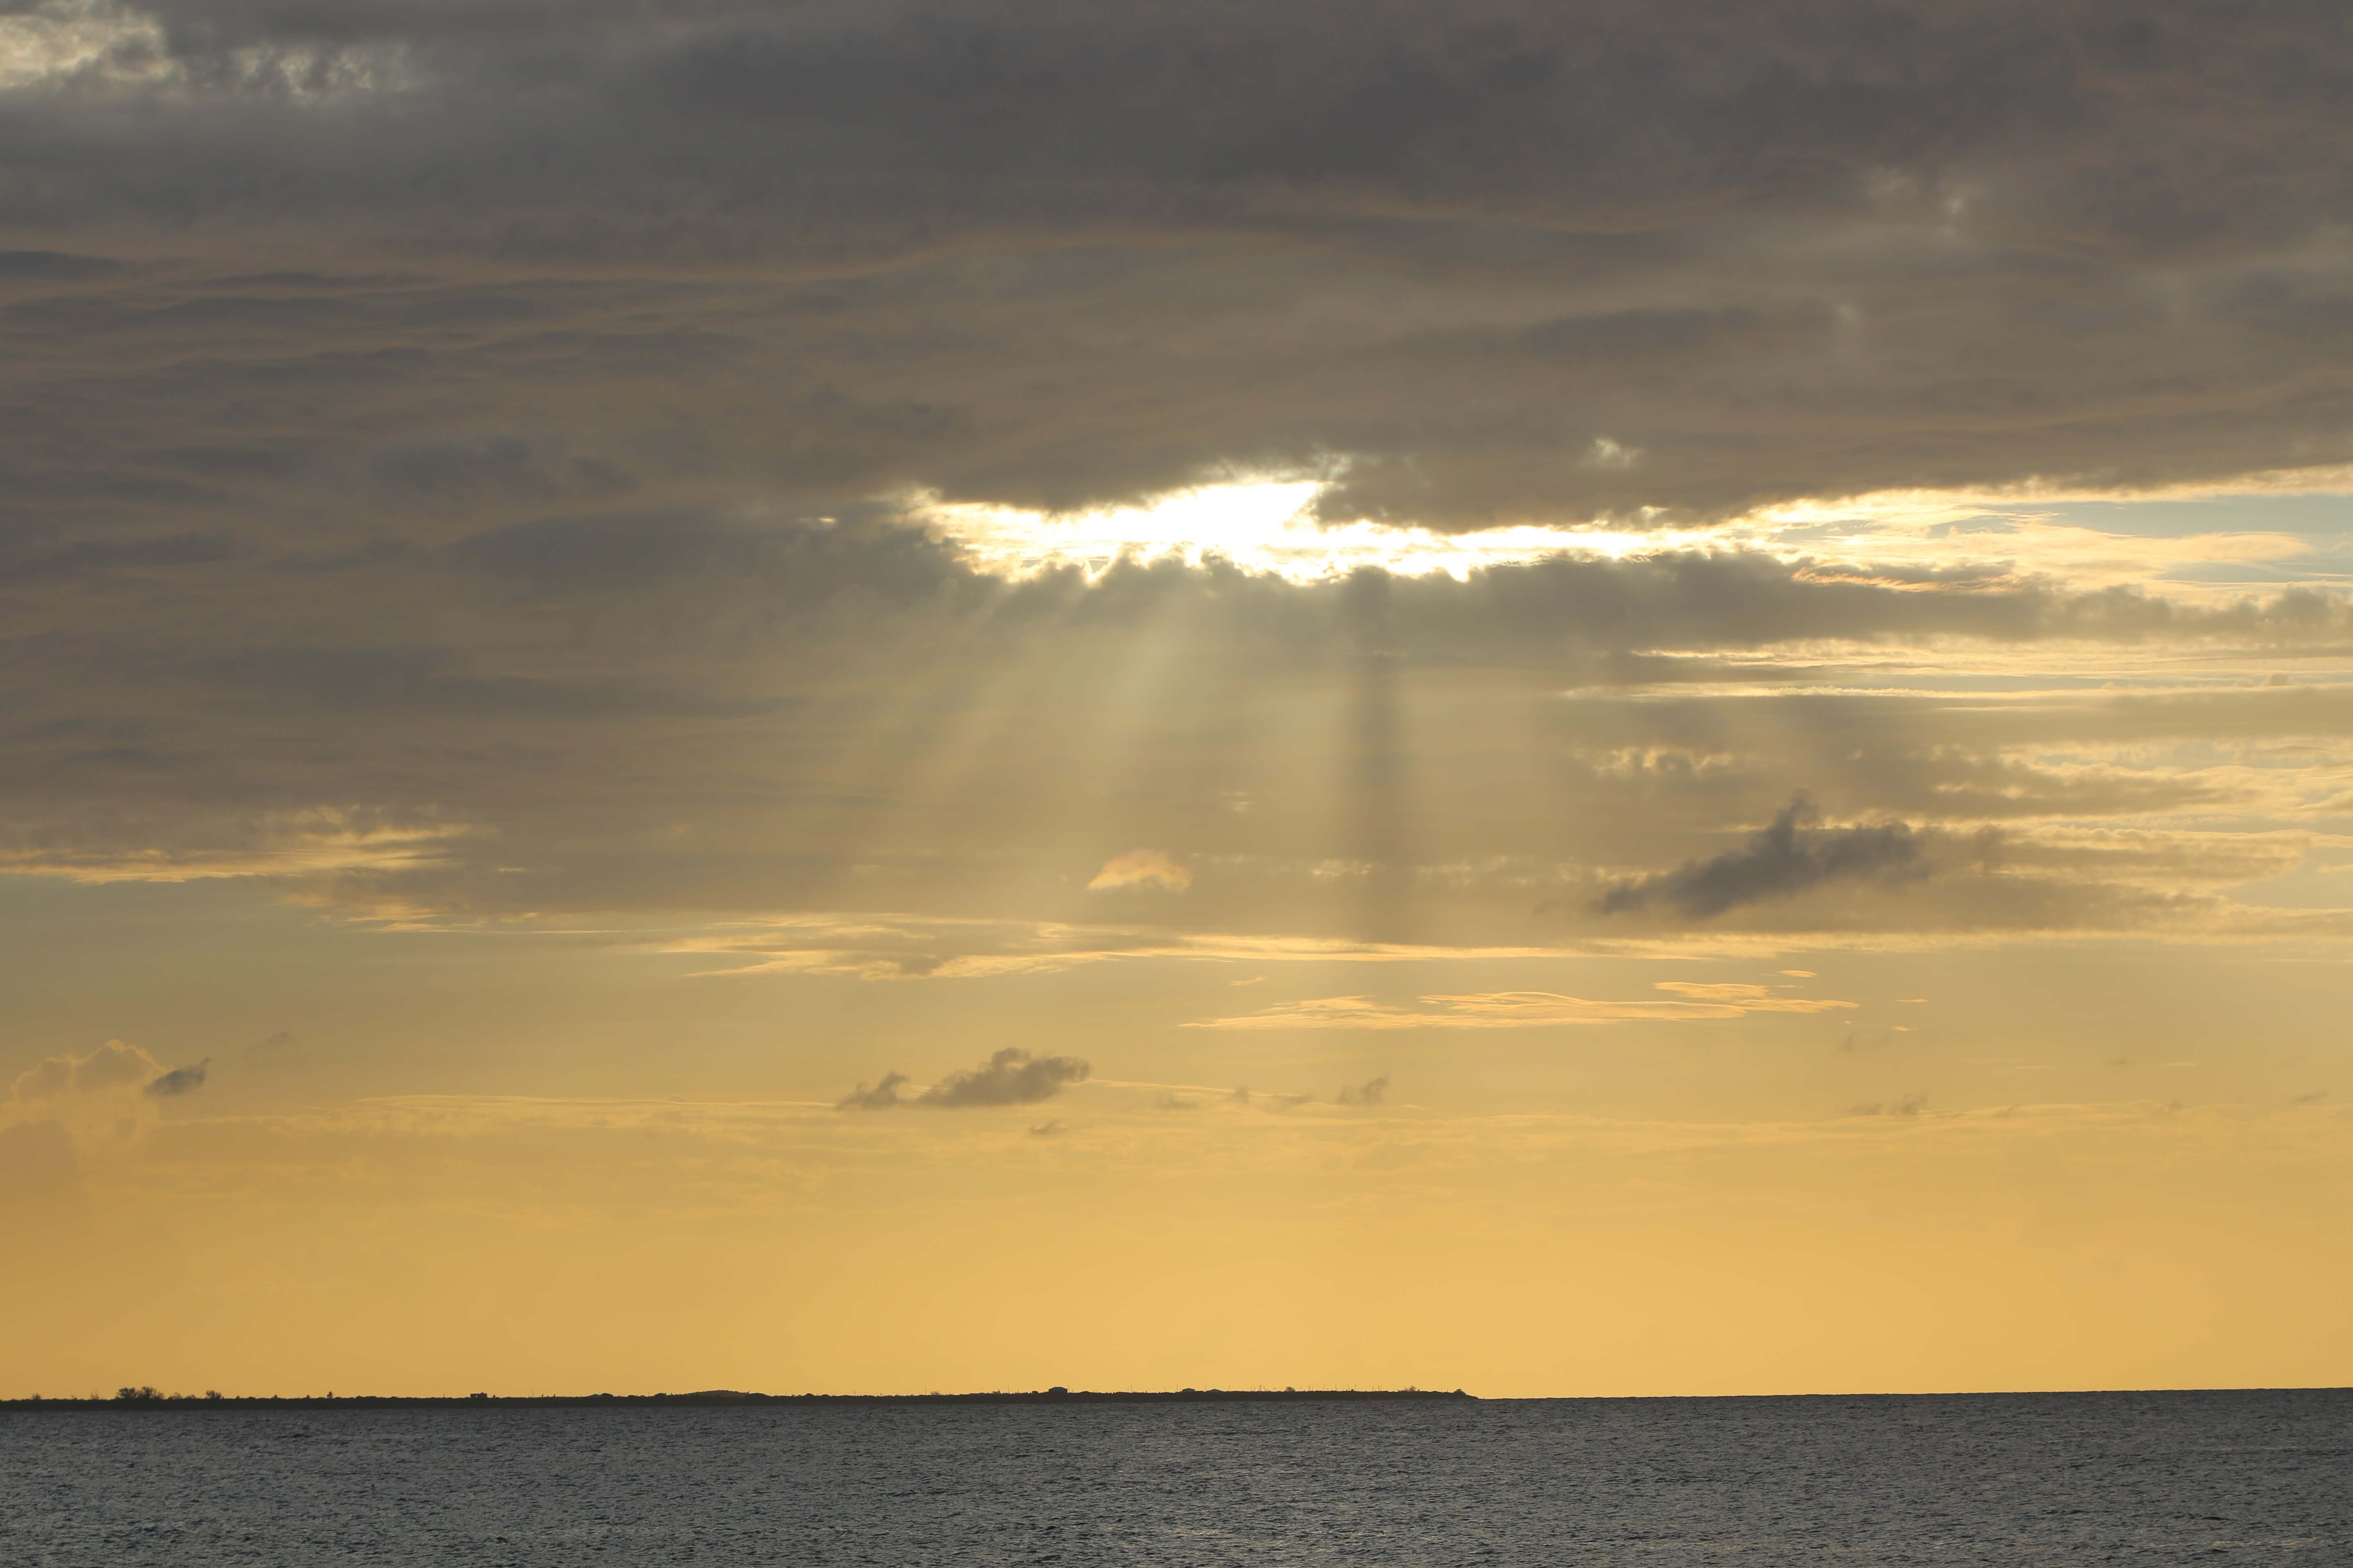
[{"left": 0, "top": 0, "right": 2353, "bottom": 1396}]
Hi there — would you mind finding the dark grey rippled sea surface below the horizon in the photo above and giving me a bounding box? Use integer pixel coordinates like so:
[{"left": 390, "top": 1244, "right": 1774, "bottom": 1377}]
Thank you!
[{"left": 0, "top": 1392, "right": 2353, "bottom": 1568}]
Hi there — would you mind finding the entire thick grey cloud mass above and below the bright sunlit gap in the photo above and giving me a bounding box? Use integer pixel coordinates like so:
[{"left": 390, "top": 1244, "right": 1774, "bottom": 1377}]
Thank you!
[{"left": 0, "top": 0, "right": 2353, "bottom": 959}]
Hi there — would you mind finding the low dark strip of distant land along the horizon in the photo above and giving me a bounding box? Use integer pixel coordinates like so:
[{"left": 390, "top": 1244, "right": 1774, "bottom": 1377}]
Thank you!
[{"left": 0, "top": 1387, "right": 1477, "bottom": 1410}]
